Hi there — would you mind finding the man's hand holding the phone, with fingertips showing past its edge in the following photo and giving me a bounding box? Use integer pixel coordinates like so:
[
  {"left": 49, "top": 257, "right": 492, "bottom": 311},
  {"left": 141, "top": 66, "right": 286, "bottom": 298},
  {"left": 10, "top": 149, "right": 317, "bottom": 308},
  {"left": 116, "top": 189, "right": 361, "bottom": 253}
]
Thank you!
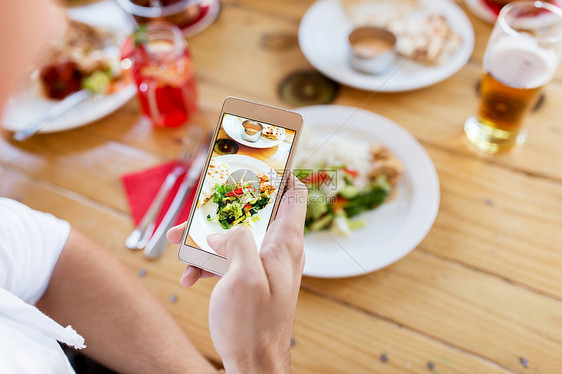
[{"left": 168, "top": 177, "right": 307, "bottom": 373}]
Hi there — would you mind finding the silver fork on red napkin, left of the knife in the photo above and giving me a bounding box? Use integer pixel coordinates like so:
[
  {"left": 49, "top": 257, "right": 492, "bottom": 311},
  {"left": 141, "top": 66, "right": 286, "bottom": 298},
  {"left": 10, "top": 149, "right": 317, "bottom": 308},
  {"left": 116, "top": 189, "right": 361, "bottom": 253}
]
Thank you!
[{"left": 125, "top": 127, "right": 205, "bottom": 250}]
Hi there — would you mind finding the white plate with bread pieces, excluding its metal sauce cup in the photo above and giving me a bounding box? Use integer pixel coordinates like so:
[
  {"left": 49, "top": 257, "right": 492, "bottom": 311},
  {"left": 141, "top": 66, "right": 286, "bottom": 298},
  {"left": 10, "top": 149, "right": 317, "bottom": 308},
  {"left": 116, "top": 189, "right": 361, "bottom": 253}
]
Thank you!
[{"left": 299, "top": 0, "right": 474, "bottom": 92}]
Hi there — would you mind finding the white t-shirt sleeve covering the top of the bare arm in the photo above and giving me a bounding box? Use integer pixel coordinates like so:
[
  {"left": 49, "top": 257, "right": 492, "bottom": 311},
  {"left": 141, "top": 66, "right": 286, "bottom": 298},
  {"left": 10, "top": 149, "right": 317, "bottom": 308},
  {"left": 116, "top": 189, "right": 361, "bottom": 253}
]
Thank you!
[{"left": 0, "top": 198, "right": 70, "bottom": 304}]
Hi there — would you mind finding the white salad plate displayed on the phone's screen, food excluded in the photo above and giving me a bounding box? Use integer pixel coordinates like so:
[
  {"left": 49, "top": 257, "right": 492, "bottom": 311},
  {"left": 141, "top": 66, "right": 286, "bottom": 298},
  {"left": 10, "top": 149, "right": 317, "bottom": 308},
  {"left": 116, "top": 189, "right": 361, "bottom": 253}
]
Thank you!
[{"left": 189, "top": 155, "right": 280, "bottom": 252}]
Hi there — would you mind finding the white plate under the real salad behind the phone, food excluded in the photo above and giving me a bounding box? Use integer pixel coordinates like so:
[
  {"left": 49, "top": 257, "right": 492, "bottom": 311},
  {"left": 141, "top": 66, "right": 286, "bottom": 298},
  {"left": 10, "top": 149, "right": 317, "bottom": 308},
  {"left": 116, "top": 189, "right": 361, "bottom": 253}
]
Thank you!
[{"left": 295, "top": 105, "right": 439, "bottom": 278}]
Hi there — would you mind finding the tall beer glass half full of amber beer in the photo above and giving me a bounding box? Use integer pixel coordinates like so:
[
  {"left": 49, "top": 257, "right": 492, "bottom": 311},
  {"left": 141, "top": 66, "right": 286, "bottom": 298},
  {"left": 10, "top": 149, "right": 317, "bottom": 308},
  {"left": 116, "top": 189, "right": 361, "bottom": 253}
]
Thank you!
[{"left": 464, "top": 1, "right": 562, "bottom": 154}]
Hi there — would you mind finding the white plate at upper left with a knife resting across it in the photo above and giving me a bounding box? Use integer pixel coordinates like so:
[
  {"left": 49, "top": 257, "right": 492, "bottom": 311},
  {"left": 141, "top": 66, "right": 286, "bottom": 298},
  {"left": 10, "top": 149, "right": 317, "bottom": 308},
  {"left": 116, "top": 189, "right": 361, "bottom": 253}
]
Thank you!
[{"left": 2, "top": 1, "right": 136, "bottom": 132}]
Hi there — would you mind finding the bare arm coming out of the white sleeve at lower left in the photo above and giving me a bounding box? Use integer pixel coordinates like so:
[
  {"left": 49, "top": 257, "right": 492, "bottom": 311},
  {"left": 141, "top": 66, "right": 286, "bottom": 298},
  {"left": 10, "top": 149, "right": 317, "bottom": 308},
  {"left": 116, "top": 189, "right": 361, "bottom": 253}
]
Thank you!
[{"left": 37, "top": 231, "right": 216, "bottom": 374}]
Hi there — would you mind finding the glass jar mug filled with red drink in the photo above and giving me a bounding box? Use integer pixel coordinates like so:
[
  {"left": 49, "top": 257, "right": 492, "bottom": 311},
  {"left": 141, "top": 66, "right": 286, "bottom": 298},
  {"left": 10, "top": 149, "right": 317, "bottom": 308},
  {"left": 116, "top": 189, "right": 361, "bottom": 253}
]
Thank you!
[{"left": 122, "top": 22, "right": 197, "bottom": 127}]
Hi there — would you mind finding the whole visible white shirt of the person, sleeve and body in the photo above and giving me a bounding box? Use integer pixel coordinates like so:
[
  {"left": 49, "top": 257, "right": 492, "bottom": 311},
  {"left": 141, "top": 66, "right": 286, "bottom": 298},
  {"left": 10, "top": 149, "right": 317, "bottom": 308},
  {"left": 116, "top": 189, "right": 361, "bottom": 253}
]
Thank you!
[{"left": 0, "top": 198, "right": 84, "bottom": 374}]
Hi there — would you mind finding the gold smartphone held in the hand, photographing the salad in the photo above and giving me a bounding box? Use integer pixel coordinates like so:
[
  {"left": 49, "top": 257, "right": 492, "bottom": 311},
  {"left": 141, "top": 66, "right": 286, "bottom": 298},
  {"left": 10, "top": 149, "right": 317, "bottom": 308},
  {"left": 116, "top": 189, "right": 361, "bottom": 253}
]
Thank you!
[{"left": 178, "top": 97, "right": 303, "bottom": 275}]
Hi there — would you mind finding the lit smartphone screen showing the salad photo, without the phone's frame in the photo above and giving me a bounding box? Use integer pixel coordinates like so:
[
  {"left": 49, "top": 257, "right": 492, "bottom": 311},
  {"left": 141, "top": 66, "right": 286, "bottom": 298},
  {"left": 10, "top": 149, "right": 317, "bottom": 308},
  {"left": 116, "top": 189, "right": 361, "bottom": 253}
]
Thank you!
[{"left": 184, "top": 113, "right": 296, "bottom": 254}]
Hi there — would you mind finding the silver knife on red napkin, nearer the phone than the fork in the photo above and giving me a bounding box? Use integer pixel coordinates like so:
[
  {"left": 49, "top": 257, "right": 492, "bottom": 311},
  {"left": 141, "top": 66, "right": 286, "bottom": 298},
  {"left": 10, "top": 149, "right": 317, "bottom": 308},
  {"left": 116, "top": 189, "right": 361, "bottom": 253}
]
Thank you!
[{"left": 144, "top": 147, "right": 207, "bottom": 260}]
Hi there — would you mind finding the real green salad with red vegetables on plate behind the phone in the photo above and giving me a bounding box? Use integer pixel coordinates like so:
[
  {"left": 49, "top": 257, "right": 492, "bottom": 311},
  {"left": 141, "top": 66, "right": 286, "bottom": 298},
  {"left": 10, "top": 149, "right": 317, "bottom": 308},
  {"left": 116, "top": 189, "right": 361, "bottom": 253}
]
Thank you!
[{"left": 295, "top": 133, "right": 402, "bottom": 236}]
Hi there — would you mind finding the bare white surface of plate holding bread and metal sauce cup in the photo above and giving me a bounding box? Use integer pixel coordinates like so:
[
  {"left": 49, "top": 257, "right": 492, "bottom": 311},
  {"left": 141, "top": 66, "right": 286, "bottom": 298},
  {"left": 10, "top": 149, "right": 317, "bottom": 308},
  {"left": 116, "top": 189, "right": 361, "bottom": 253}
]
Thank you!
[{"left": 299, "top": 0, "right": 474, "bottom": 92}]
